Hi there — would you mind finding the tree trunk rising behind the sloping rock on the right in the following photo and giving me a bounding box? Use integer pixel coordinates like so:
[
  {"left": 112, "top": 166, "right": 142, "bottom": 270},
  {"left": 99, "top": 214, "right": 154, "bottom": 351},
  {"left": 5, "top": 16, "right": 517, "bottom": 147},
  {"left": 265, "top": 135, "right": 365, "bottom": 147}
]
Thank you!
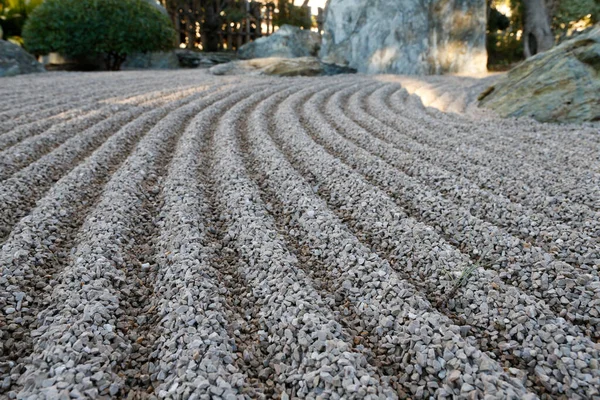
[{"left": 523, "top": 0, "right": 554, "bottom": 58}]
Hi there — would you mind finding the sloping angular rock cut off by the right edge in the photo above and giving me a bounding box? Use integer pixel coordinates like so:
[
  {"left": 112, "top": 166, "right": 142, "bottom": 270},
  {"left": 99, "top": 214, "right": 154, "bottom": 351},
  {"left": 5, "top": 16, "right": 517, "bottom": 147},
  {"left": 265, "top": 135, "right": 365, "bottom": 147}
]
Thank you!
[{"left": 479, "top": 25, "right": 600, "bottom": 122}]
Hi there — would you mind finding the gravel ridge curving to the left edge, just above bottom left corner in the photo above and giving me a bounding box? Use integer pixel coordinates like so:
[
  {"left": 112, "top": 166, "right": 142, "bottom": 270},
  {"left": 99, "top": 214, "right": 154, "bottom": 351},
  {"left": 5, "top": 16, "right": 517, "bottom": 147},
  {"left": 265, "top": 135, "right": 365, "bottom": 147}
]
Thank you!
[{"left": 0, "top": 90, "right": 204, "bottom": 391}]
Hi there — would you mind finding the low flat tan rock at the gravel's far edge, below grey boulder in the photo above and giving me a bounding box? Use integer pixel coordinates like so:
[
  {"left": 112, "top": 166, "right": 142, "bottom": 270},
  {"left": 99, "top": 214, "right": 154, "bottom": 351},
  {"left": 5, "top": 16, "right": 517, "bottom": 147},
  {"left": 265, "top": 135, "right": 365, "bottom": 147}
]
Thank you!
[{"left": 209, "top": 57, "right": 323, "bottom": 76}]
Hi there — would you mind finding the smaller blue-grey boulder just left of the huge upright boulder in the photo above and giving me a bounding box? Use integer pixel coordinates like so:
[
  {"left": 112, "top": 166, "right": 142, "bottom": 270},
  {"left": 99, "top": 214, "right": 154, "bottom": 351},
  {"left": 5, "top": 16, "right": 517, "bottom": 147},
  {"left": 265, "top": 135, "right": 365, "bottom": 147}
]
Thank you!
[{"left": 238, "top": 25, "right": 321, "bottom": 60}]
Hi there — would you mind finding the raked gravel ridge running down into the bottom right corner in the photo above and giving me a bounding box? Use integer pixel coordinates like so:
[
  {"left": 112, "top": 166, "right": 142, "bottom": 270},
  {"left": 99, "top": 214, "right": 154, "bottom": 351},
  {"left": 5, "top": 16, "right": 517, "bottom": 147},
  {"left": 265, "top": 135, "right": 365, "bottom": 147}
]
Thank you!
[{"left": 268, "top": 80, "right": 600, "bottom": 395}]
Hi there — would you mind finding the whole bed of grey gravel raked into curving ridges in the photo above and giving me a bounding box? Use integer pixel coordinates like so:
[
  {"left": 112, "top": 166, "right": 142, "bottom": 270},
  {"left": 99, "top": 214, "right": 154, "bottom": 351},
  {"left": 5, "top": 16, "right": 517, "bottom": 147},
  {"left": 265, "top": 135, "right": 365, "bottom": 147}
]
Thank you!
[{"left": 0, "top": 71, "right": 600, "bottom": 399}]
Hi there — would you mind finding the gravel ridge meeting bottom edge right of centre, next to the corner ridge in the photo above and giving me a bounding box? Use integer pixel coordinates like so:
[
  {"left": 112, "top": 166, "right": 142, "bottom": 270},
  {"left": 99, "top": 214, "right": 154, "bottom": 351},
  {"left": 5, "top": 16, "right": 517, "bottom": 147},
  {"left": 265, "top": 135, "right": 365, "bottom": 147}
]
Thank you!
[{"left": 241, "top": 79, "right": 526, "bottom": 398}]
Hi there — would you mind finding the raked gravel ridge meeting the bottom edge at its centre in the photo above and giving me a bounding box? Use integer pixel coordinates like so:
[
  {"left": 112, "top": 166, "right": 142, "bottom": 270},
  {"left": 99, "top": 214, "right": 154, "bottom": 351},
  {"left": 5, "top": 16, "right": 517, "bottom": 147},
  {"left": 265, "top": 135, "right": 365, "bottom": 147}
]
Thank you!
[{"left": 213, "top": 83, "right": 393, "bottom": 398}]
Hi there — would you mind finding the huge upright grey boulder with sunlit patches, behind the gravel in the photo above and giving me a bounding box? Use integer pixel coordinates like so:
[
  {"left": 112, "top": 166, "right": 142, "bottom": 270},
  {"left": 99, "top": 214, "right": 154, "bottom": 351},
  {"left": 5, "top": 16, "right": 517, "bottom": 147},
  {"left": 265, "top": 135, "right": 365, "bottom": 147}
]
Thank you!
[{"left": 320, "top": 0, "right": 487, "bottom": 75}]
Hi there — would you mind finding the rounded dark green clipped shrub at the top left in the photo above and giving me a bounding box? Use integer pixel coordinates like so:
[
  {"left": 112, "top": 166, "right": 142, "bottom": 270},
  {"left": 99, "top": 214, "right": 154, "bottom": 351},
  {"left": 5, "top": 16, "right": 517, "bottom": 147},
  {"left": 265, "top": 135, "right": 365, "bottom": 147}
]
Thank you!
[{"left": 23, "top": 0, "right": 175, "bottom": 71}]
